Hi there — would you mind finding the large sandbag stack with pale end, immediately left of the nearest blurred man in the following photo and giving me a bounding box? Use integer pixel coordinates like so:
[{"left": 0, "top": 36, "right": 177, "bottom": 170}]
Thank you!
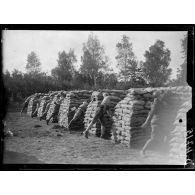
[{"left": 112, "top": 89, "right": 153, "bottom": 147}]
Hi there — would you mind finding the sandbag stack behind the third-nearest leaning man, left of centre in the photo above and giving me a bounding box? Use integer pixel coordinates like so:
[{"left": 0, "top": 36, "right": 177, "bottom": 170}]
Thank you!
[{"left": 58, "top": 90, "right": 92, "bottom": 131}]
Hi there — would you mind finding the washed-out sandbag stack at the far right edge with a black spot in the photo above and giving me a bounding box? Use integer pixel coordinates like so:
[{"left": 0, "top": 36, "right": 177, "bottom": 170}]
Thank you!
[{"left": 170, "top": 87, "right": 192, "bottom": 164}]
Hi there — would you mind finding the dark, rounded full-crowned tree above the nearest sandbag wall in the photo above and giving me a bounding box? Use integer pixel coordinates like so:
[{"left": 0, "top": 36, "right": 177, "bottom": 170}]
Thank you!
[{"left": 142, "top": 40, "right": 172, "bottom": 87}]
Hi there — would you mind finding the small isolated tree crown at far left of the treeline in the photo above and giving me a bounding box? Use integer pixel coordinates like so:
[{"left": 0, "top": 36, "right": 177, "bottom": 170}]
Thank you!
[{"left": 26, "top": 51, "right": 41, "bottom": 74}]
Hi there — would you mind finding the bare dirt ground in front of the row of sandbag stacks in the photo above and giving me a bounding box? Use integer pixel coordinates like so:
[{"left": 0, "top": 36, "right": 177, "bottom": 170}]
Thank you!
[{"left": 3, "top": 112, "right": 171, "bottom": 165}]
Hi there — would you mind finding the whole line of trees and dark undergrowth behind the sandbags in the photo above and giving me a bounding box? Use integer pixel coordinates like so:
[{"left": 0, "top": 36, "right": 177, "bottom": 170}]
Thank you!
[{"left": 4, "top": 33, "right": 187, "bottom": 101}]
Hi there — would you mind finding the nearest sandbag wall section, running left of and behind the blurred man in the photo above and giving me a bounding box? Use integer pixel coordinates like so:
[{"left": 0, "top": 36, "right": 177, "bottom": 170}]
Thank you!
[{"left": 112, "top": 87, "right": 190, "bottom": 151}]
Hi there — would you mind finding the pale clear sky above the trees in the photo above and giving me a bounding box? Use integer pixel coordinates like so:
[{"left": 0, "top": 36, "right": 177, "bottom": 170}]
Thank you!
[{"left": 3, "top": 30, "right": 187, "bottom": 78}]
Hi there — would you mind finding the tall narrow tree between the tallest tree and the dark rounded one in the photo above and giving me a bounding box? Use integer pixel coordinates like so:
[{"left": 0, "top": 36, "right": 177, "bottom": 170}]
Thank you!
[{"left": 115, "top": 35, "right": 138, "bottom": 83}]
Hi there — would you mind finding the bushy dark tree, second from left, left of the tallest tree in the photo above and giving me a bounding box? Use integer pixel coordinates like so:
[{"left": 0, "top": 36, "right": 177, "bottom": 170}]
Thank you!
[{"left": 51, "top": 49, "right": 77, "bottom": 87}]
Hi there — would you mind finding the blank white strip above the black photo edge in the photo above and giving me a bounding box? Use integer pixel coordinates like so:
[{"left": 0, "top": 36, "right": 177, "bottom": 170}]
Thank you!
[{"left": 0, "top": 0, "right": 195, "bottom": 24}]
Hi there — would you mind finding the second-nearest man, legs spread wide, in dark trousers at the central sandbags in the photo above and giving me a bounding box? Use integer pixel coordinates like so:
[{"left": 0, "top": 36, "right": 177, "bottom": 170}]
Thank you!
[{"left": 83, "top": 93, "right": 111, "bottom": 138}]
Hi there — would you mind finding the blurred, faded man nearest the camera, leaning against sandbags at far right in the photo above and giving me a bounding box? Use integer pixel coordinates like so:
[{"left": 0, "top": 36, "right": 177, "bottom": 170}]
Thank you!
[{"left": 141, "top": 91, "right": 171, "bottom": 156}]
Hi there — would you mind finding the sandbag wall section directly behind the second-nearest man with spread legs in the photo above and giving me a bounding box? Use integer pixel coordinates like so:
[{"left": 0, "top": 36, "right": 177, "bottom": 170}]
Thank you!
[{"left": 84, "top": 90, "right": 127, "bottom": 138}]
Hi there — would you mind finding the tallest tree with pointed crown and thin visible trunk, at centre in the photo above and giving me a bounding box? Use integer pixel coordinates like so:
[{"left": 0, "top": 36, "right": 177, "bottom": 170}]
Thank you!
[{"left": 80, "top": 33, "right": 108, "bottom": 87}]
